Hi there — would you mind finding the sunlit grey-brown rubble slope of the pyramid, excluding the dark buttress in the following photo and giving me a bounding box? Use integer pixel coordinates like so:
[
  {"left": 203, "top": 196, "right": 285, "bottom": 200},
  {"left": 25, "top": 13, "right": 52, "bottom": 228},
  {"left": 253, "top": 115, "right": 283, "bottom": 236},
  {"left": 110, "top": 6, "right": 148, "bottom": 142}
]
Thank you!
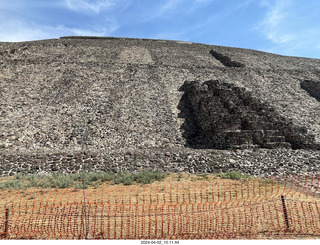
[{"left": 0, "top": 37, "right": 320, "bottom": 175}]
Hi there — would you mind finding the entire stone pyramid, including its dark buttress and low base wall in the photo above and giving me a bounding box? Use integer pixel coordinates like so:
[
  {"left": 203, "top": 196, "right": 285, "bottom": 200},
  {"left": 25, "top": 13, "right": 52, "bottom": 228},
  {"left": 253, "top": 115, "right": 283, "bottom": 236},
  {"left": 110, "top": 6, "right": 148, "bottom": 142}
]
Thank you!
[{"left": 0, "top": 37, "right": 320, "bottom": 175}]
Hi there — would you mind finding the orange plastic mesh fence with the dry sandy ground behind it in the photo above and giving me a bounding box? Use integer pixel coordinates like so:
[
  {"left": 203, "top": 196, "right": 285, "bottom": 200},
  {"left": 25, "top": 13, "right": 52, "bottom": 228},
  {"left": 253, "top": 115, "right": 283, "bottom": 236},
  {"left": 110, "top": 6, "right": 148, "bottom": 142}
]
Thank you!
[{"left": 0, "top": 175, "right": 320, "bottom": 239}]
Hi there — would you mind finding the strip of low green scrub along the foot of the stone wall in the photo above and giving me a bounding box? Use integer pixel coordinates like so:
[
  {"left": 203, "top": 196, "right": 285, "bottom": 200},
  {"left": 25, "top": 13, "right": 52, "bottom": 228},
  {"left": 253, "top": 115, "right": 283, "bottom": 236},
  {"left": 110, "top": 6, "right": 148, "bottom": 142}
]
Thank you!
[{"left": 0, "top": 171, "right": 255, "bottom": 190}]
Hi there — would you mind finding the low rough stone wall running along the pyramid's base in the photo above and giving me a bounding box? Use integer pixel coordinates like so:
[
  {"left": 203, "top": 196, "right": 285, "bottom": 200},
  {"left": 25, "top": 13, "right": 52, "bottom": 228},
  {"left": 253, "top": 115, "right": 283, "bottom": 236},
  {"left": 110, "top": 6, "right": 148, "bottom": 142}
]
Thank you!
[{"left": 0, "top": 148, "right": 320, "bottom": 176}]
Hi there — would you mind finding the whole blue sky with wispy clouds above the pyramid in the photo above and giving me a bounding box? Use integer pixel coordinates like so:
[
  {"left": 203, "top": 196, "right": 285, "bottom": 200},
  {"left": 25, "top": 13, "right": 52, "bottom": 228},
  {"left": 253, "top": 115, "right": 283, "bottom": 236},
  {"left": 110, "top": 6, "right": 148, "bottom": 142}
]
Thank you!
[{"left": 0, "top": 0, "right": 320, "bottom": 59}]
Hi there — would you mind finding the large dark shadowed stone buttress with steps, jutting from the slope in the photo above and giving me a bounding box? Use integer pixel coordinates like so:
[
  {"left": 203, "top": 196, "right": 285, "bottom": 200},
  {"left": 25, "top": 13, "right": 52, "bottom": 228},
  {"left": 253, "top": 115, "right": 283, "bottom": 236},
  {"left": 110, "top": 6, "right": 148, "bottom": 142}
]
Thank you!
[{"left": 184, "top": 80, "right": 319, "bottom": 149}]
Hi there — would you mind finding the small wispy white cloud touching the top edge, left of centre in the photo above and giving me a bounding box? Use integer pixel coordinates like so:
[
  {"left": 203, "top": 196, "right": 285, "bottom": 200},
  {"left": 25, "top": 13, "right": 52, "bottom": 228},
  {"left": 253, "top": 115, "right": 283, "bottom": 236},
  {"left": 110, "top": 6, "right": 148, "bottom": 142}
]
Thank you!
[{"left": 65, "top": 0, "right": 116, "bottom": 13}]
